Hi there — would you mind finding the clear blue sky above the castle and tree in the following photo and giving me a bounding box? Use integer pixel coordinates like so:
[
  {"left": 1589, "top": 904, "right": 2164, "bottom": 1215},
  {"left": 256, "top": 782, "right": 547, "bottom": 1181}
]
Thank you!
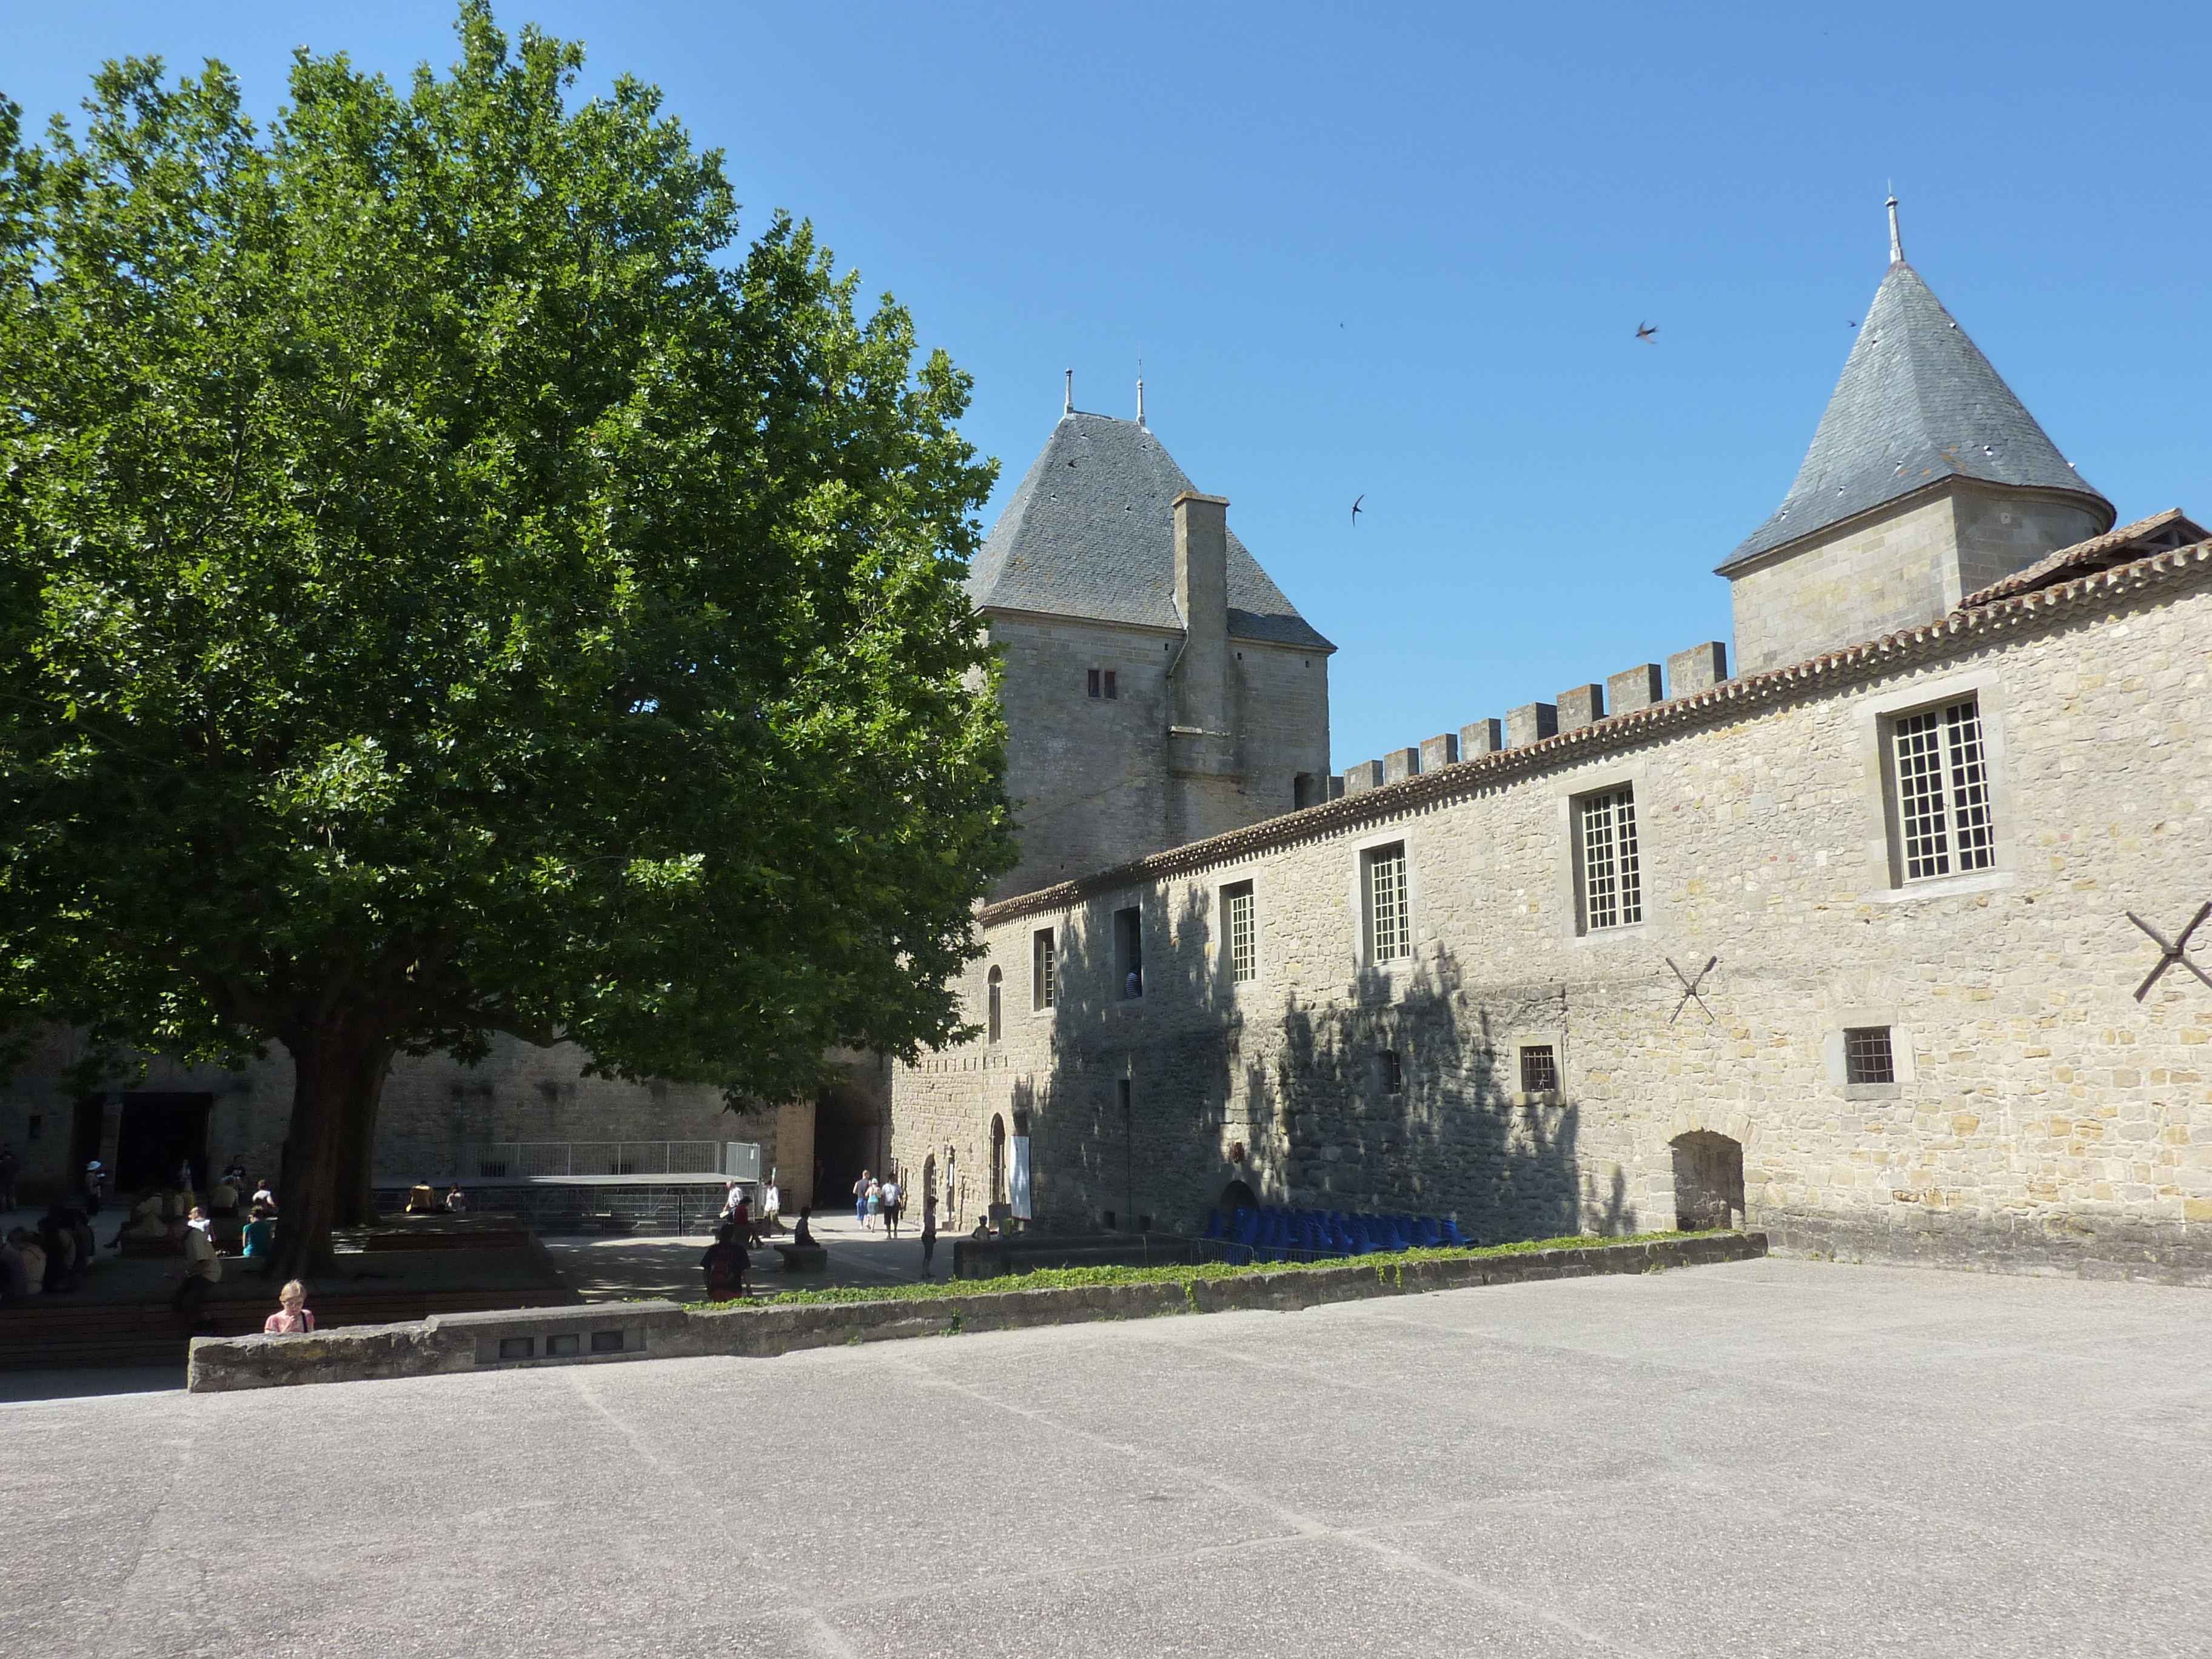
[{"left": 0, "top": 0, "right": 2212, "bottom": 770}]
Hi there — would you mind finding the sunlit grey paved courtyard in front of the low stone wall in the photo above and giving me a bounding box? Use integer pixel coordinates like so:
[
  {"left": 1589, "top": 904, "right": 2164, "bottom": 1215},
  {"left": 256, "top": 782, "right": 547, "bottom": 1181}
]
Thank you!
[{"left": 13, "top": 1261, "right": 2212, "bottom": 1659}]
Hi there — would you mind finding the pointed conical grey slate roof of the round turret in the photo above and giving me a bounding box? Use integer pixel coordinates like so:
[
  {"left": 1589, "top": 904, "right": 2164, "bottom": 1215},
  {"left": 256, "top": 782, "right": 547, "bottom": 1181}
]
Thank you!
[{"left": 1721, "top": 259, "right": 2114, "bottom": 575}]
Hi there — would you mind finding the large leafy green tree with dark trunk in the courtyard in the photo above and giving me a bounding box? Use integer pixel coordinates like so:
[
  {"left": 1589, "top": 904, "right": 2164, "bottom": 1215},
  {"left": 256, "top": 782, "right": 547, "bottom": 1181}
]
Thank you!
[{"left": 0, "top": 4, "right": 1011, "bottom": 1265}]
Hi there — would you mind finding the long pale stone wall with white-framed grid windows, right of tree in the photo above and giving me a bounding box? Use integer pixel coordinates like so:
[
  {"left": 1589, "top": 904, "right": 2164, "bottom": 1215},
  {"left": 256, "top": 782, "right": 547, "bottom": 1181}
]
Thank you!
[{"left": 894, "top": 551, "right": 2212, "bottom": 1281}]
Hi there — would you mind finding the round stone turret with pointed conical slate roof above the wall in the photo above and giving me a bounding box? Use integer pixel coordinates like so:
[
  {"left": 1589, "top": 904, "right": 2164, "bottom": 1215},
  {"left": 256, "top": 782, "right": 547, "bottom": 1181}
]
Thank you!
[{"left": 1718, "top": 199, "right": 2114, "bottom": 672}]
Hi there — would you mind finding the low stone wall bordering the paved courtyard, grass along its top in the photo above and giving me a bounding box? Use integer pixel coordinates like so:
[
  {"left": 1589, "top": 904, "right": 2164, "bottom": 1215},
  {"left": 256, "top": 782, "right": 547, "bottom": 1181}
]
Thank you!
[{"left": 186, "top": 1232, "right": 1768, "bottom": 1393}]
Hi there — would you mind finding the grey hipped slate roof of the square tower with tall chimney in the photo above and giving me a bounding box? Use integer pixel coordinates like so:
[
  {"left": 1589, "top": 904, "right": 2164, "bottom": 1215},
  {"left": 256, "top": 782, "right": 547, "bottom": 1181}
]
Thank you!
[{"left": 969, "top": 414, "right": 1336, "bottom": 651}]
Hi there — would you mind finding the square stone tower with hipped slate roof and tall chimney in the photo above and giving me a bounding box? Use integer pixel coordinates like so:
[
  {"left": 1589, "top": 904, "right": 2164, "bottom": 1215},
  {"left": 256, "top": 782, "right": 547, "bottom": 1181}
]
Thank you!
[{"left": 969, "top": 409, "right": 1336, "bottom": 896}]
